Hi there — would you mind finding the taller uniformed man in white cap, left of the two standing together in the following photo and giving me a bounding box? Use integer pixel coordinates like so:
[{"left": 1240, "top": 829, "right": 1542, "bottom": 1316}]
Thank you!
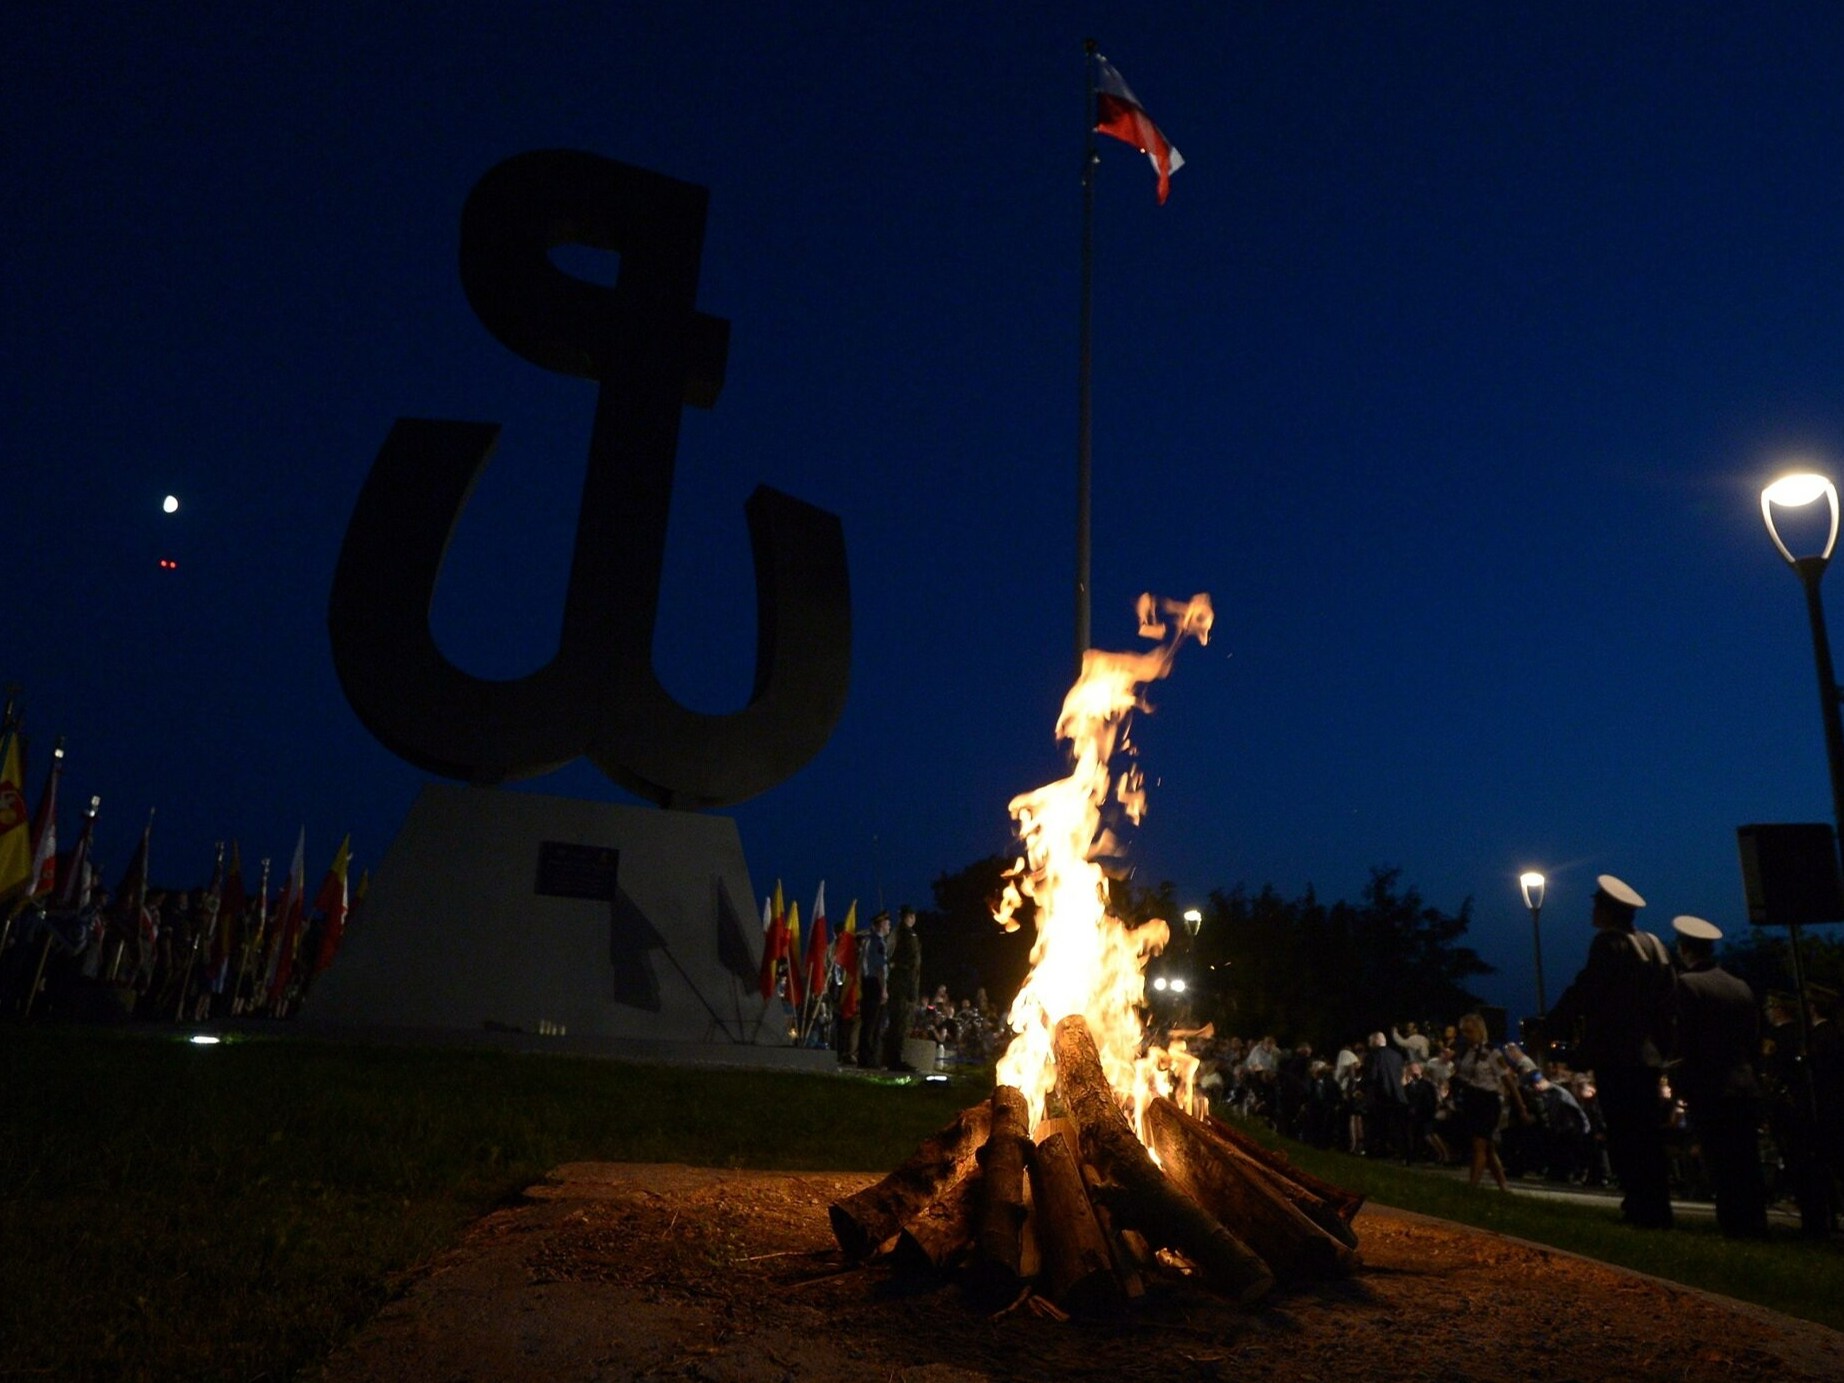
[{"left": 1549, "top": 874, "right": 1676, "bottom": 1230}]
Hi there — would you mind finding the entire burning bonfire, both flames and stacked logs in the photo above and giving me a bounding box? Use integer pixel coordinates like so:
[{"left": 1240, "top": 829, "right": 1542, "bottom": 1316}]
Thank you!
[{"left": 830, "top": 596, "right": 1363, "bottom": 1315}]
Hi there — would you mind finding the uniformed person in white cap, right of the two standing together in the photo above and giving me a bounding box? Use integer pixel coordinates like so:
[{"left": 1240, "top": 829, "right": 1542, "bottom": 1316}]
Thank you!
[{"left": 1671, "top": 916, "right": 1767, "bottom": 1239}]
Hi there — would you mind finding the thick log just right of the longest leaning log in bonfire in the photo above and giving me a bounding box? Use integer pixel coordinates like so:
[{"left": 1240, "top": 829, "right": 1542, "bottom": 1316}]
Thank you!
[{"left": 1147, "top": 1099, "right": 1352, "bottom": 1282}]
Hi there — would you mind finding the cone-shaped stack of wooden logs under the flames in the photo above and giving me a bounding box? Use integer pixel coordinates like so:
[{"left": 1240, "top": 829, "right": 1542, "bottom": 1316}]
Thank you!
[{"left": 830, "top": 1018, "right": 1363, "bottom": 1317}]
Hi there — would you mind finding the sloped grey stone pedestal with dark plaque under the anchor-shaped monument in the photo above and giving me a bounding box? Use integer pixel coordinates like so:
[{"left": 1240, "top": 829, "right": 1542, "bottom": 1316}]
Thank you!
[{"left": 301, "top": 784, "right": 832, "bottom": 1070}]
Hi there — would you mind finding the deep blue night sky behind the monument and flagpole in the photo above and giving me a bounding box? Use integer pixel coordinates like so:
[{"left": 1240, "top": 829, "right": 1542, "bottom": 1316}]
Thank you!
[{"left": 0, "top": 2, "right": 1844, "bottom": 1009}]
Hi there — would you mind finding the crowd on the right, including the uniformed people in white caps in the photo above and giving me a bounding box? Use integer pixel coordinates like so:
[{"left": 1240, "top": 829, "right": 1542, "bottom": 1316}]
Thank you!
[{"left": 1158, "top": 876, "right": 1844, "bottom": 1237}]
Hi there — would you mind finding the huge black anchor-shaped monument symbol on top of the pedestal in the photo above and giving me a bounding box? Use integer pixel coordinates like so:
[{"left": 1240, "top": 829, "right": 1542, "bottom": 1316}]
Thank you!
[{"left": 326, "top": 149, "right": 852, "bottom": 808}]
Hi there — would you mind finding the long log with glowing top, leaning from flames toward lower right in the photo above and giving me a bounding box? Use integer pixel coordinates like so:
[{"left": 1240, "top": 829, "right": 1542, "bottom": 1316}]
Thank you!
[{"left": 1053, "top": 1014, "right": 1274, "bottom": 1304}]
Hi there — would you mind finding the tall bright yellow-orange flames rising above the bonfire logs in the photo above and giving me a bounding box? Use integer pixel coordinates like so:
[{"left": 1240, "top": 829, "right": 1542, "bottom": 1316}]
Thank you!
[{"left": 994, "top": 596, "right": 1215, "bottom": 1127}]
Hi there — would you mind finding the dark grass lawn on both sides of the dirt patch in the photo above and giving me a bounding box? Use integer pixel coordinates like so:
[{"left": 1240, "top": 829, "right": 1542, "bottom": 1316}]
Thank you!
[{"left": 0, "top": 1027, "right": 1844, "bottom": 1379}]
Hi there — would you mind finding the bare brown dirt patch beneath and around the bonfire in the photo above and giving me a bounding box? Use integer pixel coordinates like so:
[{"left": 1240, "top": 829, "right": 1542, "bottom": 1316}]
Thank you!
[{"left": 317, "top": 1164, "right": 1844, "bottom": 1383}]
